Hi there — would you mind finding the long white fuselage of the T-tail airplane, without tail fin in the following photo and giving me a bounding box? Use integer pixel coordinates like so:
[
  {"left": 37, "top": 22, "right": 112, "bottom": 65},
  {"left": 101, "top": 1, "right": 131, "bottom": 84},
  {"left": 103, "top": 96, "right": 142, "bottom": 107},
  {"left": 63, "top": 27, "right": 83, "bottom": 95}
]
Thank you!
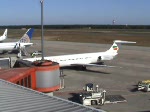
[{"left": 24, "top": 52, "right": 118, "bottom": 67}]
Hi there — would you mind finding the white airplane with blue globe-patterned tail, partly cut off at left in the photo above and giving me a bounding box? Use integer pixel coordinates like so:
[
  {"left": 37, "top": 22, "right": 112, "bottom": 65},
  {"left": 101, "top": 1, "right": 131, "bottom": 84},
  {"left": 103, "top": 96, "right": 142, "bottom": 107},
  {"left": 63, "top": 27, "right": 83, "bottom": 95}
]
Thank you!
[{"left": 0, "top": 28, "right": 34, "bottom": 55}]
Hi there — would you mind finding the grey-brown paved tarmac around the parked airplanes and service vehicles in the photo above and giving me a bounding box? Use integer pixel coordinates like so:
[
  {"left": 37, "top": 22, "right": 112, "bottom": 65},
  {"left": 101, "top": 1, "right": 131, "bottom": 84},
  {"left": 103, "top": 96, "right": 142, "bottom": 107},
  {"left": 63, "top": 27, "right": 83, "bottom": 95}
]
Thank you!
[{"left": 1, "top": 40, "right": 150, "bottom": 112}]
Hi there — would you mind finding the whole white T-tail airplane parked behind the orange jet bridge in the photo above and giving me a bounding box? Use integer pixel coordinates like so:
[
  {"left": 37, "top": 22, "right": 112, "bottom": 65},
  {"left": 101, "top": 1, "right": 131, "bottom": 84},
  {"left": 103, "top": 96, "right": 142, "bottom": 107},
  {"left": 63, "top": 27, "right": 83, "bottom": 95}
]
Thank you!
[{"left": 23, "top": 40, "right": 136, "bottom": 70}]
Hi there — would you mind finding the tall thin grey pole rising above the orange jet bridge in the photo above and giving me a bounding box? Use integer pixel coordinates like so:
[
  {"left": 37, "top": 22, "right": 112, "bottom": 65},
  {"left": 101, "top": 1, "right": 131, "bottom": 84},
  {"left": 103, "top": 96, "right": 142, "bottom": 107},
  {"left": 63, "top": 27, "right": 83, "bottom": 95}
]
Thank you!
[{"left": 40, "top": 0, "right": 44, "bottom": 61}]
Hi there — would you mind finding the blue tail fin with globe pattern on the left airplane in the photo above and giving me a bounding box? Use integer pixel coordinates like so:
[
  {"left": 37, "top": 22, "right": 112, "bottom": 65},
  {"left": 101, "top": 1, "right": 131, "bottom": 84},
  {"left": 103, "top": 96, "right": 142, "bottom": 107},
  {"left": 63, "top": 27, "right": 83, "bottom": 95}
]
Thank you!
[{"left": 18, "top": 28, "right": 34, "bottom": 43}]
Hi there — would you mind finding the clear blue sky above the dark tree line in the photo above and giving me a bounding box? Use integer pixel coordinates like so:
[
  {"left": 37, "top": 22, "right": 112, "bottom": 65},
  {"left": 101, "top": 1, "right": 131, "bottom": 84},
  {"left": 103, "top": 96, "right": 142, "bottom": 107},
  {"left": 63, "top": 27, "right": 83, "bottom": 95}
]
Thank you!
[{"left": 0, "top": 0, "right": 150, "bottom": 25}]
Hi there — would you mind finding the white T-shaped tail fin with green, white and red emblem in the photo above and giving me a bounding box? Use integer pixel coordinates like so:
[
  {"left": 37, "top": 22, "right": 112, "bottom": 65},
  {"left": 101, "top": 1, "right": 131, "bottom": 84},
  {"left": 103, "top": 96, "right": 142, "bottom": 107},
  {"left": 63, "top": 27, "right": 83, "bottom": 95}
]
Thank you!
[{"left": 106, "top": 40, "right": 136, "bottom": 53}]
